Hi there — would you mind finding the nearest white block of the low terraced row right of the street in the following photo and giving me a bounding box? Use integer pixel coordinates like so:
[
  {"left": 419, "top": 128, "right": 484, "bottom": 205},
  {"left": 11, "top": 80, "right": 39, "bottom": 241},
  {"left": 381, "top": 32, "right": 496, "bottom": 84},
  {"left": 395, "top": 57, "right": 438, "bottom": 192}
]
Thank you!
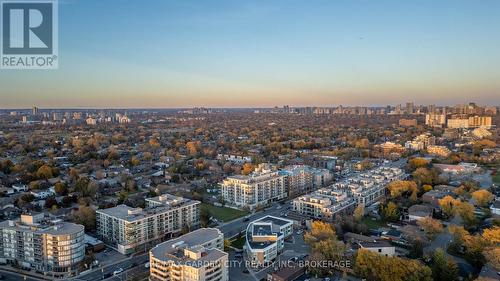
[{"left": 292, "top": 188, "right": 356, "bottom": 221}]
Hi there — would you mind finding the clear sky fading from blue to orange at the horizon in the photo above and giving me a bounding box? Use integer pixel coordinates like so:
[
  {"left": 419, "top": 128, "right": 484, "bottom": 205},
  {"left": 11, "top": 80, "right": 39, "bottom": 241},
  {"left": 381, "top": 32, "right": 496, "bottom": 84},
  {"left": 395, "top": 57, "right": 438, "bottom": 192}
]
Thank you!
[{"left": 0, "top": 0, "right": 500, "bottom": 108}]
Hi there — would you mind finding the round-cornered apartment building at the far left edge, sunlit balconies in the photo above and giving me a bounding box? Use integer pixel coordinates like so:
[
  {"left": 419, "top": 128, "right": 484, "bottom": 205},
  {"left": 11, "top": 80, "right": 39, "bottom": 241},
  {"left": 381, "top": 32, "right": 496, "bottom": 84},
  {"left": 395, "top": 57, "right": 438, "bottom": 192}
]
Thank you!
[{"left": 0, "top": 214, "right": 85, "bottom": 278}]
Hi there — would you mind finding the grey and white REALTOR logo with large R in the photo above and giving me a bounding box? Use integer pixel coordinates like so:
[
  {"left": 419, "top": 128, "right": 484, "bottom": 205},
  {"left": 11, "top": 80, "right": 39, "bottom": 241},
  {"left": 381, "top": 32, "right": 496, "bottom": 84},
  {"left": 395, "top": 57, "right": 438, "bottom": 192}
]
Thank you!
[{"left": 0, "top": 0, "right": 58, "bottom": 69}]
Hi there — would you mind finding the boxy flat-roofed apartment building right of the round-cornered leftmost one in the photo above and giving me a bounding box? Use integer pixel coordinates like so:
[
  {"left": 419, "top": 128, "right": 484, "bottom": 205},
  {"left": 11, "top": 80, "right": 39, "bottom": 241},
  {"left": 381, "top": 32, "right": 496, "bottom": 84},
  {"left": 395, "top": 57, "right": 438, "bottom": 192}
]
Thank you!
[{"left": 96, "top": 194, "right": 201, "bottom": 254}]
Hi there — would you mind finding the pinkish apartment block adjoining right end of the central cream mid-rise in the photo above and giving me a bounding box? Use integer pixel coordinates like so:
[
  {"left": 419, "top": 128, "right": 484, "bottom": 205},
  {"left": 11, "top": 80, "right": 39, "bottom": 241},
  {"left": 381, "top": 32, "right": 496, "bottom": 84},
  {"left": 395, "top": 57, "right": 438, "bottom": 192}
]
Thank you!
[{"left": 280, "top": 165, "right": 333, "bottom": 197}]
